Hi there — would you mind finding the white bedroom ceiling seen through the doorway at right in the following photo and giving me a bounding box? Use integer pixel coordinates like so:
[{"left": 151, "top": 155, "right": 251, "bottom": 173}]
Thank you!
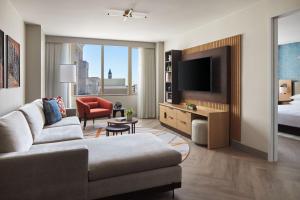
[{"left": 278, "top": 11, "right": 300, "bottom": 44}]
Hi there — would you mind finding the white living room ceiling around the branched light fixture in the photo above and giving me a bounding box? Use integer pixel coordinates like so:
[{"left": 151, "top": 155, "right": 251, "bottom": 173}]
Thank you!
[{"left": 11, "top": 0, "right": 257, "bottom": 42}]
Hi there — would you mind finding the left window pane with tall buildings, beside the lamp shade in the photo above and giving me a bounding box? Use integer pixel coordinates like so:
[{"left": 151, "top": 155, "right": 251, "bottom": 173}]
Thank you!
[{"left": 72, "top": 44, "right": 101, "bottom": 95}]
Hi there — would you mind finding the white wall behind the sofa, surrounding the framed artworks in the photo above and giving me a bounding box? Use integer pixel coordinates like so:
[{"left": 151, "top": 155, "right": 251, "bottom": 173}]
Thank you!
[{"left": 0, "top": 0, "right": 25, "bottom": 115}]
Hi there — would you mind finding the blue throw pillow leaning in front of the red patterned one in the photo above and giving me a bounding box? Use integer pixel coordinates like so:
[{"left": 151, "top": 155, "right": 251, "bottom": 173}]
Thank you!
[{"left": 43, "top": 99, "right": 61, "bottom": 125}]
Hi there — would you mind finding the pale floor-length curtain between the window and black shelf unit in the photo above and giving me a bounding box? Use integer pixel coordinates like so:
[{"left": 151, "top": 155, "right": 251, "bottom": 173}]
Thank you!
[{"left": 137, "top": 48, "right": 156, "bottom": 118}]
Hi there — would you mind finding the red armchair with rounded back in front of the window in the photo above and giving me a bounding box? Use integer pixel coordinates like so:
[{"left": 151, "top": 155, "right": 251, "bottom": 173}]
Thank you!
[{"left": 76, "top": 97, "right": 113, "bottom": 129}]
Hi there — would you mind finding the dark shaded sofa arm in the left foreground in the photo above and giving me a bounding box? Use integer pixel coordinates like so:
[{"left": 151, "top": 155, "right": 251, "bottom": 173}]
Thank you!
[{"left": 0, "top": 146, "right": 88, "bottom": 199}]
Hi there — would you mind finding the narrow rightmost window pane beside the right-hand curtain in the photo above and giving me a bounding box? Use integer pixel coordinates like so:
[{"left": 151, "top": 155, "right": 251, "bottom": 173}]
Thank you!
[{"left": 131, "top": 48, "right": 139, "bottom": 94}]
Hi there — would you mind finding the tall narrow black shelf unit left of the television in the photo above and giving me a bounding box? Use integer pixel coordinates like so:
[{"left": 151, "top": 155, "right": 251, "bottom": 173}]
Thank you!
[{"left": 165, "top": 50, "right": 181, "bottom": 104}]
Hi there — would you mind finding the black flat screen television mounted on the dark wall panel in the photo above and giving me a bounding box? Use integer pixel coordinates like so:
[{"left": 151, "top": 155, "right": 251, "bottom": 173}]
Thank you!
[{"left": 178, "top": 57, "right": 212, "bottom": 92}]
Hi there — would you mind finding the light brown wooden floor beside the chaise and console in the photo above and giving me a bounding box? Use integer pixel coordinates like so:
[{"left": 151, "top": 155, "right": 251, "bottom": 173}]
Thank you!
[{"left": 127, "top": 120, "right": 300, "bottom": 200}]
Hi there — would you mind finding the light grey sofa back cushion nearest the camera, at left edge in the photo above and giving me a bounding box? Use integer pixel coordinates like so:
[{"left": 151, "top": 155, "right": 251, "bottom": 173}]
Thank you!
[{"left": 0, "top": 111, "right": 33, "bottom": 153}]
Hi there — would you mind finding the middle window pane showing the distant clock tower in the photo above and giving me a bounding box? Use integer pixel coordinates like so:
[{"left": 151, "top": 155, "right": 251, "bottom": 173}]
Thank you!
[{"left": 104, "top": 46, "right": 128, "bottom": 94}]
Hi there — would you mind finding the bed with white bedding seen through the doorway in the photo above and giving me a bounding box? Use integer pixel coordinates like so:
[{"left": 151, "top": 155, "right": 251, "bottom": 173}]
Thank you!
[{"left": 278, "top": 94, "right": 300, "bottom": 136}]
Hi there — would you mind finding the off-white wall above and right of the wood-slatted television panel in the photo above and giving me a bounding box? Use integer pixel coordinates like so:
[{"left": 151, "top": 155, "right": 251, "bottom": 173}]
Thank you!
[{"left": 165, "top": 0, "right": 300, "bottom": 152}]
